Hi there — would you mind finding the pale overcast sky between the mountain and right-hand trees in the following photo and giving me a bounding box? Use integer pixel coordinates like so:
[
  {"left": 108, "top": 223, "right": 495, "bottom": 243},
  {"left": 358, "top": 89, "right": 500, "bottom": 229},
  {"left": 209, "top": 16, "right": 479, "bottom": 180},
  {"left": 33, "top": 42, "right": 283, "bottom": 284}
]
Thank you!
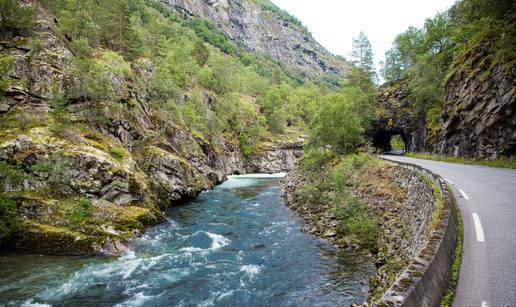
[{"left": 272, "top": 0, "right": 455, "bottom": 76}]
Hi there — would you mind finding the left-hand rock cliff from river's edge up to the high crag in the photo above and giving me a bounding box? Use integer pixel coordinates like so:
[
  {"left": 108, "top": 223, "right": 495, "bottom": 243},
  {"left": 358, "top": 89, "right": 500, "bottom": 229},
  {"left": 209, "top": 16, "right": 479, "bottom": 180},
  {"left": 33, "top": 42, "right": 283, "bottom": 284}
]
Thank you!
[{"left": 0, "top": 4, "right": 302, "bottom": 254}]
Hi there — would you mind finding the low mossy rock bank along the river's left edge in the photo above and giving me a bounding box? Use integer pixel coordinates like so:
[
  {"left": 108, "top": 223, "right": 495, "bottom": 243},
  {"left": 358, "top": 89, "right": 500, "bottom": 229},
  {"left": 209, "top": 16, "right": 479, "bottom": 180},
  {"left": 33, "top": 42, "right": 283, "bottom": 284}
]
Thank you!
[{"left": 0, "top": 128, "right": 300, "bottom": 254}]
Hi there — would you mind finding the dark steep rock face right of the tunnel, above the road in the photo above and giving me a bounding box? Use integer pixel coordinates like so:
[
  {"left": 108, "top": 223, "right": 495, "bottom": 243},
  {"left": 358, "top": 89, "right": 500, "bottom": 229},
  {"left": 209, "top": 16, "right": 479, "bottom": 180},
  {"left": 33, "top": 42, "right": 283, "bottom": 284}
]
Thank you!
[{"left": 435, "top": 32, "right": 516, "bottom": 158}]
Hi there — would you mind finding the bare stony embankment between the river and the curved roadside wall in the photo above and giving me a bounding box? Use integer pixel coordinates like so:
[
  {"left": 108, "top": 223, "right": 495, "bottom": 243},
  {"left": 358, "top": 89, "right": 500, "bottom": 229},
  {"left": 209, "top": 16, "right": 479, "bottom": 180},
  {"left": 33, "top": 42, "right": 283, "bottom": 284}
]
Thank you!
[{"left": 283, "top": 162, "right": 434, "bottom": 302}]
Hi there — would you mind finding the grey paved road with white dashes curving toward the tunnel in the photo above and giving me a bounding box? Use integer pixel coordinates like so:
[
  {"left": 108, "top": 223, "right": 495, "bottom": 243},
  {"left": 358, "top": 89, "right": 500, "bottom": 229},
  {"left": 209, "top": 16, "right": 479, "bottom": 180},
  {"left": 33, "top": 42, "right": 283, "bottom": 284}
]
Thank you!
[{"left": 382, "top": 156, "right": 516, "bottom": 307}]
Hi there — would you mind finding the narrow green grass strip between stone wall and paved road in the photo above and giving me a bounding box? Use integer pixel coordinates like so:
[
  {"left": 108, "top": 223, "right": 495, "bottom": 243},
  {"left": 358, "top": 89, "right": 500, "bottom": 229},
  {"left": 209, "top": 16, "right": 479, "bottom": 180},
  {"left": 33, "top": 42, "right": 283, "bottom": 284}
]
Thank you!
[{"left": 441, "top": 186, "right": 463, "bottom": 307}]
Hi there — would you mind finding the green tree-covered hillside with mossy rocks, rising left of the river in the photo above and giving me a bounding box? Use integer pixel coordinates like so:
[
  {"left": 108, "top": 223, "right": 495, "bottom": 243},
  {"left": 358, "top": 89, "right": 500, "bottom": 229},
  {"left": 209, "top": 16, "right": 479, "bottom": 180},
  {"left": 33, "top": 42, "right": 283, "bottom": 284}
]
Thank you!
[{"left": 0, "top": 0, "right": 374, "bottom": 253}]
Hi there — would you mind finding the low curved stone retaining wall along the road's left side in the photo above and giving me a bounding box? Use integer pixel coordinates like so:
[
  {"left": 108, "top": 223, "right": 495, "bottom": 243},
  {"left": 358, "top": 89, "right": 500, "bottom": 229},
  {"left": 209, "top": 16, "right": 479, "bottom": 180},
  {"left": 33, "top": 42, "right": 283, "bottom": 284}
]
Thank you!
[{"left": 374, "top": 162, "right": 458, "bottom": 307}]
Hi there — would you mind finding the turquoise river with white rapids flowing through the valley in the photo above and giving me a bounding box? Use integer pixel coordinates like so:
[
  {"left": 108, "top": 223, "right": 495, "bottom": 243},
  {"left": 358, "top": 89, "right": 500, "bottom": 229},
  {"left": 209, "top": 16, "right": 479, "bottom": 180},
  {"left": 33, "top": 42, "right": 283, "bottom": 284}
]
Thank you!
[{"left": 0, "top": 176, "right": 373, "bottom": 306}]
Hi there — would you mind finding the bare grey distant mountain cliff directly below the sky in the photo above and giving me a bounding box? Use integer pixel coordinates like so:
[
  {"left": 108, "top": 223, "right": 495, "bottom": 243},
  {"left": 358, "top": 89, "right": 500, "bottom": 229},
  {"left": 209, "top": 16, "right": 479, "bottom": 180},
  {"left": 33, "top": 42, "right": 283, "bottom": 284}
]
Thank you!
[{"left": 162, "top": 0, "right": 348, "bottom": 77}]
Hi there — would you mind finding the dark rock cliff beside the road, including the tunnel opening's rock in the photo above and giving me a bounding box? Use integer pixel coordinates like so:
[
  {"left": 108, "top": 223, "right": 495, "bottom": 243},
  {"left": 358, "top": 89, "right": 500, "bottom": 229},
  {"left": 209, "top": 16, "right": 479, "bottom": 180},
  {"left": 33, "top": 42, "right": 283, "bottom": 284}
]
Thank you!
[{"left": 369, "top": 20, "right": 516, "bottom": 159}]
